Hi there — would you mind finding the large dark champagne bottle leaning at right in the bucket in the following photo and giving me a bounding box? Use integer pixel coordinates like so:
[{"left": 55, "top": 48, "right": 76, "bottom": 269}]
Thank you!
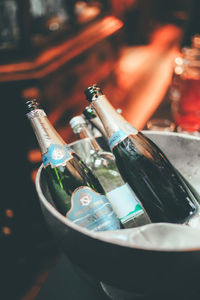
[{"left": 85, "top": 85, "right": 198, "bottom": 223}]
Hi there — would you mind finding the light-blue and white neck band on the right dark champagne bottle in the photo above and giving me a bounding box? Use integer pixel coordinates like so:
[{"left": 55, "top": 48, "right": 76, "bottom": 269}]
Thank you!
[{"left": 108, "top": 122, "right": 138, "bottom": 150}]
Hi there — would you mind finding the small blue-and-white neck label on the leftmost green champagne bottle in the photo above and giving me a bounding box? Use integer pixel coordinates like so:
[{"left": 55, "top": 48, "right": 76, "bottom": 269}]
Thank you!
[{"left": 42, "top": 144, "right": 73, "bottom": 168}]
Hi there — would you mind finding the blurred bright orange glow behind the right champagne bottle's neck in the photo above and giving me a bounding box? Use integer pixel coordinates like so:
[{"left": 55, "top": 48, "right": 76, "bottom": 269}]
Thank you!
[{"left": 114, "top": 25, "right": 181, "bottom": 130}]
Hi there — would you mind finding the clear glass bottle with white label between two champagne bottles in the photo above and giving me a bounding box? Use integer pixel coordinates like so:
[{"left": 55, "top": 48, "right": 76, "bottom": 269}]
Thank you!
[{"left": 70, "top": 116, "right": 150, "bottom": 228}]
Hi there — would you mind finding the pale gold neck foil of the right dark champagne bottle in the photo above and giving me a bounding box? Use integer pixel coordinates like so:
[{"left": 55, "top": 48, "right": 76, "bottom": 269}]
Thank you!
[{"left": 92, "top": 95, "right": 138, "bottom": 139}]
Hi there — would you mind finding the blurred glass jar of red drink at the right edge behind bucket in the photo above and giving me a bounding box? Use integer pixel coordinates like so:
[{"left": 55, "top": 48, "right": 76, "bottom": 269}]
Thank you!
[{"left": 170, "top": 35, "right": 200, "bottom": 133}]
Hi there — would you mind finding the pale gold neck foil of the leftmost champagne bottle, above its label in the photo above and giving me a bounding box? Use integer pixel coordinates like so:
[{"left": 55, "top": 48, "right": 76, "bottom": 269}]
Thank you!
[{"left": 27, "top": 109, "right": 66, "bottom": 155}]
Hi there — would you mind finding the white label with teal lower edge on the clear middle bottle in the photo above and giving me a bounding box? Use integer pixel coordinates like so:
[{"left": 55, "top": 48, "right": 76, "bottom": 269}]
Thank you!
[{"left": 106, "top": 183, "right": 144, "bottom": 224}]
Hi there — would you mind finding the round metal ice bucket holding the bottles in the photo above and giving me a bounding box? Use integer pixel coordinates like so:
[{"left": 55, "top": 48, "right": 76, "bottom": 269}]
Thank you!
[{"left": 36, "top": 131, "right": 200, "bottom": 299}]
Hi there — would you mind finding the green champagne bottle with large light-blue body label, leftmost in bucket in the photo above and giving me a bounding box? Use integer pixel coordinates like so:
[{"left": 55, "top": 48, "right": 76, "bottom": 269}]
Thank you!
[{"left": 26, "top": 100, "right": 120, "bottom": 231}]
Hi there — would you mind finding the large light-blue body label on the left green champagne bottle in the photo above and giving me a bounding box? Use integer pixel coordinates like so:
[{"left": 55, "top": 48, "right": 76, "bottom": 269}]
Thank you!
[{"left": 66, "top": 186, "right": 120, "bottom": 231}]
